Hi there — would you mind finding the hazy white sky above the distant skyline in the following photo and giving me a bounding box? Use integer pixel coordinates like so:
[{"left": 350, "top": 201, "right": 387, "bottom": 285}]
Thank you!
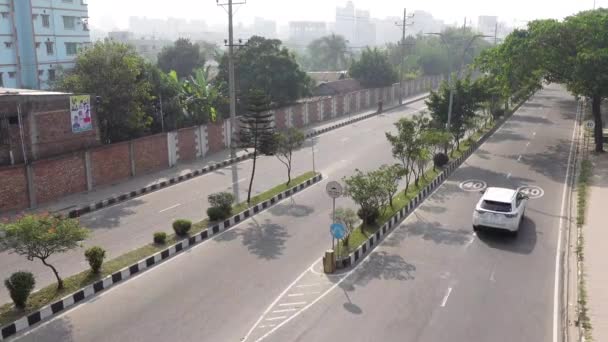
[{"left": 88, "top": 0, "right": 608, "bottom": 30}]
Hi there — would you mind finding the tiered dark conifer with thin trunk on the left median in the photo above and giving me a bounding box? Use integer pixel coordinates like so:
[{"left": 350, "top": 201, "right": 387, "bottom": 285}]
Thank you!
[{"left": 237, "top": 90, "right": 275, "bottom": 204}]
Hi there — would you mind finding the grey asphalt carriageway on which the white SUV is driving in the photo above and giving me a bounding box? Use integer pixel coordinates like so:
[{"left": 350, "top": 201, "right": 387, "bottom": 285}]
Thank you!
[{"left": 252, "top": 85, "right": 576, "bottom": 342}]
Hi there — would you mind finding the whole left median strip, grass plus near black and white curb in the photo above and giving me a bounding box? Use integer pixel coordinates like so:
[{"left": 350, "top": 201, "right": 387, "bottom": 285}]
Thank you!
[{"left": 0, "top": 172, "right": 323, "bottom": 340}]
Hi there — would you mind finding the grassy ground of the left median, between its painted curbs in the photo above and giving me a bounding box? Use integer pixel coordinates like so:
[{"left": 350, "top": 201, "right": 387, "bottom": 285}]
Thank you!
[{"left": 0, "top": 171, "right": 316, "bottom": 326}]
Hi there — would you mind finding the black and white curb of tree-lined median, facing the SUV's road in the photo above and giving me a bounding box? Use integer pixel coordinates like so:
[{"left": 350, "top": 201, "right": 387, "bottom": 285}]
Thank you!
[{"left": 336, "top": 111, "right": 519, "bottom": 268}]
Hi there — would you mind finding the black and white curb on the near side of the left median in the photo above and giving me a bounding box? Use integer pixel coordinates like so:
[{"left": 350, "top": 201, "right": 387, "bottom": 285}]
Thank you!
[{"left": 0, "top": 174, "right": 323, "bottom": 340}]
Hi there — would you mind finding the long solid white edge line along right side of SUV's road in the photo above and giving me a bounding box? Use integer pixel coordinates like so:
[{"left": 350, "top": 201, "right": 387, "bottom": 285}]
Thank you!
[{"left": 553, "top": 100, "right": 581, "bottom": 342}]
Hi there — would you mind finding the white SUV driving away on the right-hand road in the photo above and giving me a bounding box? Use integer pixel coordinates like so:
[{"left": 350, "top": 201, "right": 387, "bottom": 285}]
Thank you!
[{"left": 473, "top": 188, "right": 528, "bottom": 235}]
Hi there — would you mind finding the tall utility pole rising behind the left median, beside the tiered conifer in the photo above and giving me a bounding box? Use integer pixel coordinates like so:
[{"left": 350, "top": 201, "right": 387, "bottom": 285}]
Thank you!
[{"left": 216, "top": 0, "right": 245, "bottom": 203}]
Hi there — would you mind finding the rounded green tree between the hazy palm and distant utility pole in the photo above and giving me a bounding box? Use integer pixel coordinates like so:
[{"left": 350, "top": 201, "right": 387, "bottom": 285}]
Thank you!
[{"left": 349, "top": 48, "right": 398, "bottom": 88}]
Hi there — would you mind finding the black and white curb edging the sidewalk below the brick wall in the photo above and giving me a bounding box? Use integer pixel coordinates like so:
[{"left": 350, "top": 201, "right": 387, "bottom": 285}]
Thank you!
[{"left": 67, "top": 94, "right": 429, "bottom": 218}]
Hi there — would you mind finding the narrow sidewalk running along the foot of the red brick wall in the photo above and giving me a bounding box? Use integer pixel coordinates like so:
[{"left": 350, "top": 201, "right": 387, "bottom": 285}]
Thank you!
[{"left": 7, "top": 93, "right": 428, "bottom": 216}]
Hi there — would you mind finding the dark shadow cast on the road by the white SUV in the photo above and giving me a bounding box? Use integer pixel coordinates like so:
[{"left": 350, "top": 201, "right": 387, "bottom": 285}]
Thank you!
[{"left": 477, "top": 217, "right": 539, "bottom": 254}]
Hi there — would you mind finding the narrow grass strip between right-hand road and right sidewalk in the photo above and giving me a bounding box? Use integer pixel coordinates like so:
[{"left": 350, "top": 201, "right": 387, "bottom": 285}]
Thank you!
[{"left": 576, "top": 159, "right": 593, "bottom": 341}]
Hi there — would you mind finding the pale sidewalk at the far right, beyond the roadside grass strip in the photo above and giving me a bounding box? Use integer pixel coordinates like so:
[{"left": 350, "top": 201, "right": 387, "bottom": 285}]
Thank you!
[{"left": 583, "top": 154, "right": 608, "bottom": 341}]
